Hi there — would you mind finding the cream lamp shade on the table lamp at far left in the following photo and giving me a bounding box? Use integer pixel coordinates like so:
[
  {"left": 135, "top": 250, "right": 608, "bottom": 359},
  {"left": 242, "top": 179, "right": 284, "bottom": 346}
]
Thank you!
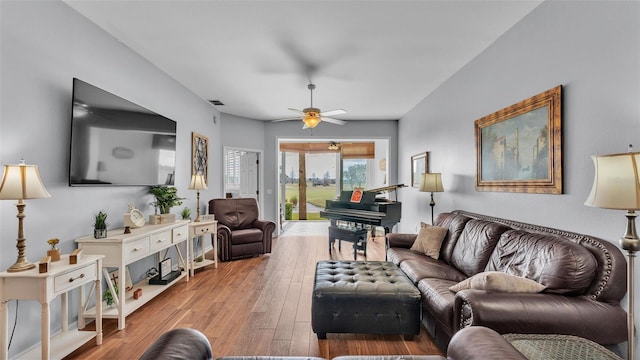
[{"left": 0, "top": 160, "right": 51, "bottom": 200}]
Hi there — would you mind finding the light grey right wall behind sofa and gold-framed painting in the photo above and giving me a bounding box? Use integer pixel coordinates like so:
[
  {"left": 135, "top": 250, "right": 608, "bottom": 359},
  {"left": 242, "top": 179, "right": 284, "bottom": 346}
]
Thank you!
[{"left": 398, "top": 1, "right": 640, "bottom": 358}]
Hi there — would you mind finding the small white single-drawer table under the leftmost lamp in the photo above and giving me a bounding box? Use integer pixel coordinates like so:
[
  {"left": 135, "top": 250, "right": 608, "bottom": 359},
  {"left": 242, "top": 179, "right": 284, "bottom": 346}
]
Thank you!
[{"left": 0, "top": 255, "right": 102, "bottom": 360}]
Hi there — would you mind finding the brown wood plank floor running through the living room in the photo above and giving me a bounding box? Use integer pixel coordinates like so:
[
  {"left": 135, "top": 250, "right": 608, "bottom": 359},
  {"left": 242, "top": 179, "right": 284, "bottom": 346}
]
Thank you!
[{"left": 66, "top": 222, "right": 442, "bottom": 359}]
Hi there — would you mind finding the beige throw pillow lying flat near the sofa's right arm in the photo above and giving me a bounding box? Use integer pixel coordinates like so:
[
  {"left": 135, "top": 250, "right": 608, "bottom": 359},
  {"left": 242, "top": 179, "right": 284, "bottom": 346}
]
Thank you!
[{"left": 449, "top": 271, "right": 546, "bottom": 293}]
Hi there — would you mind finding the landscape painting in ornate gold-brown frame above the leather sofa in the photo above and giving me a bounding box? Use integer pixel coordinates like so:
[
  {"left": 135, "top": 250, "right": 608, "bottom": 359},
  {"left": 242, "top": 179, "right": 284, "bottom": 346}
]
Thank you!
[{"left": 475, "top": 86, "right": 562, "bottom": 194}]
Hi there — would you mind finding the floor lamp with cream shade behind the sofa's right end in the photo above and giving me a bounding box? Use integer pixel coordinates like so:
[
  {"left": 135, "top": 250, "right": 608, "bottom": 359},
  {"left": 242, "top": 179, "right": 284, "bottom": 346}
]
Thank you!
[{"left": 585, "top": 152, "right": 640, "bottom": 359}]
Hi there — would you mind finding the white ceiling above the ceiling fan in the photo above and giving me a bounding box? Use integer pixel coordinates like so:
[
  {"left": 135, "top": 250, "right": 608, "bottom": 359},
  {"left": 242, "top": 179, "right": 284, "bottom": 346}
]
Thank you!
[{"left": 63, "top": 0, "right": 541, "bottom": 122}]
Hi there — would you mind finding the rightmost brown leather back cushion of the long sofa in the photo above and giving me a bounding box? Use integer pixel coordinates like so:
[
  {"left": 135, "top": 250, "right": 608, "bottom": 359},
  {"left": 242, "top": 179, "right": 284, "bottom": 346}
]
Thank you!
[{"left": 486, "top": 230, "right": 597, "bottom": 295}]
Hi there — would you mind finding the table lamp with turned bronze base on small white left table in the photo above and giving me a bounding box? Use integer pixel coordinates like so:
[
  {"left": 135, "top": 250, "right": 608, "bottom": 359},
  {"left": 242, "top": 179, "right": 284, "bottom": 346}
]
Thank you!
[{"left": 0, "top": 160, "right": 51, "bottom": 272}]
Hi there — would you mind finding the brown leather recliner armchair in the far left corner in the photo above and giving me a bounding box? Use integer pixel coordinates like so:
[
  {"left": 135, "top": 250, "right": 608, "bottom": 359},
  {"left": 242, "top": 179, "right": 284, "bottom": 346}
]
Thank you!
[{"left": 209, "top": 198, "right": 276, "bottom": 261}]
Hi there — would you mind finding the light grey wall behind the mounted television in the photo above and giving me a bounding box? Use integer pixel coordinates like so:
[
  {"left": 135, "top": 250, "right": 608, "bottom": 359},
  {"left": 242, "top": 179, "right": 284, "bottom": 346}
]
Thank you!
[{"left": 0, "top": 0, "right": 221, "bottom": 356}]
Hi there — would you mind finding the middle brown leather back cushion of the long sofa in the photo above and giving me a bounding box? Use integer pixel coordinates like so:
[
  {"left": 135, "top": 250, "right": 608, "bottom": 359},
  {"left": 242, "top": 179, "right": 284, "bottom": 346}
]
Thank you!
[{"left": 450, "top": 219, "right": 510, "bottom": 279}]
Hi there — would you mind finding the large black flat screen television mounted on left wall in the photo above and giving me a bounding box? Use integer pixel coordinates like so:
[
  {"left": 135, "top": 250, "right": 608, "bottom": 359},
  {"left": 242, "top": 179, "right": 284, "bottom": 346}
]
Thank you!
[{"left": 69, "top": 78, "right": 176, "bottom": 186}]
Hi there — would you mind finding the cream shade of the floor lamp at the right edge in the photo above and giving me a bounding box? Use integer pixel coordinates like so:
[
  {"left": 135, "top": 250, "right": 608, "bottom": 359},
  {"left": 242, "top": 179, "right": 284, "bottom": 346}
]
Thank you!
[{"left": 584, "top": 152, "right": 640, "bottom": 210}]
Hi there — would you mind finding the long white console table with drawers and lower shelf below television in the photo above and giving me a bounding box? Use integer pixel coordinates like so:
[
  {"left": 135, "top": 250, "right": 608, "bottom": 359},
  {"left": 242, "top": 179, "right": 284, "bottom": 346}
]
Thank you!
[{"left": 75, "top": 220, "right": 189, "bottom": 330}]
